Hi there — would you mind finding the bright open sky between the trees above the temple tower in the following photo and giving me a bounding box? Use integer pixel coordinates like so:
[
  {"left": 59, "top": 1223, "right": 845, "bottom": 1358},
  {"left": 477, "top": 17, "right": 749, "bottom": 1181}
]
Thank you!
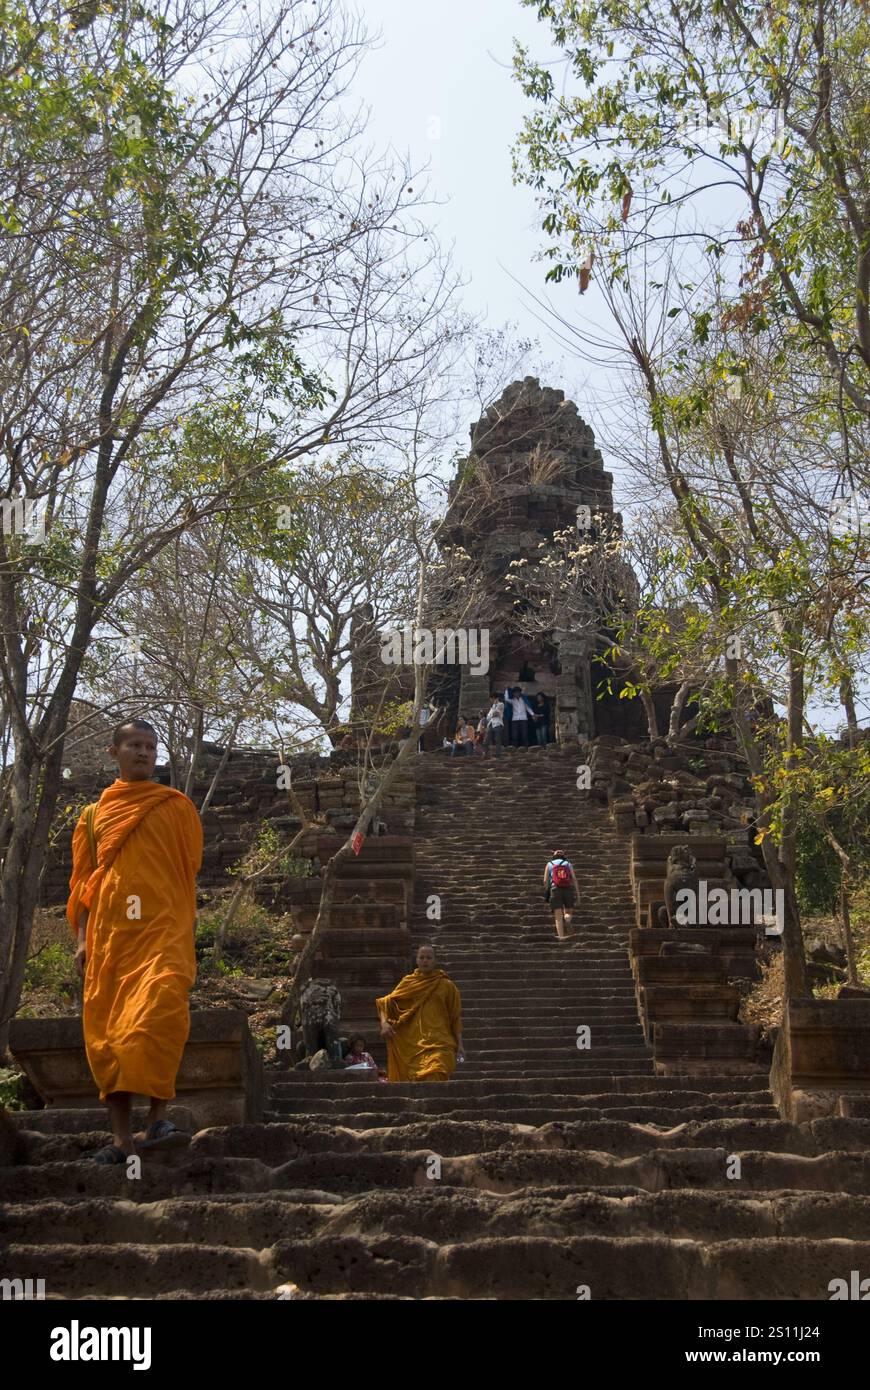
[{"left": 353, "top": 0, "right": 607, "bottom": 439}]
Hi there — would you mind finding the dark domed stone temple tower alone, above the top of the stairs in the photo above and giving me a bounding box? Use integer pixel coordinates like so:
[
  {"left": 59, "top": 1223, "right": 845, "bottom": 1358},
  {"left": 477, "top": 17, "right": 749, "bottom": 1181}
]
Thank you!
[{"left": 442, "top": 377, "right": 613, "bottom": 742}]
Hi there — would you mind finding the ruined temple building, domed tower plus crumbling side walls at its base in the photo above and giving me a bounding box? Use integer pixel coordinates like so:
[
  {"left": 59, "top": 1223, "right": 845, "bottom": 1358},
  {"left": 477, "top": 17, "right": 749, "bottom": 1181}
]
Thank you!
[{"left": 352, "top": 377, "right": 645, "bottom": 748}]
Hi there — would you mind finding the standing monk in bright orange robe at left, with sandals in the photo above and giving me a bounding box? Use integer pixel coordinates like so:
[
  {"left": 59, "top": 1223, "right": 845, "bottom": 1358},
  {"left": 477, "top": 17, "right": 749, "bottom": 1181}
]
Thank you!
[{"left": 67, "top": 720, "right": 203, "bottom": 1163}]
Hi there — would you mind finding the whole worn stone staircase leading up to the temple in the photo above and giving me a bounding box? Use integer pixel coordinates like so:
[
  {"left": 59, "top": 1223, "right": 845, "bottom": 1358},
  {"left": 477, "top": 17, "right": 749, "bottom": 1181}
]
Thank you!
[{"left": 0, "top": 748, "right": 870, "bottom": 1301}]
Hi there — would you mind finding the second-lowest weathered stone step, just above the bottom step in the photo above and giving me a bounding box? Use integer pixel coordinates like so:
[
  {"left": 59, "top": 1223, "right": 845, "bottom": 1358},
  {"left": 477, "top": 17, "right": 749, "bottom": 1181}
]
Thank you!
[{"left": 4, "top": 1182, "right": 870, "bottom": 1252}]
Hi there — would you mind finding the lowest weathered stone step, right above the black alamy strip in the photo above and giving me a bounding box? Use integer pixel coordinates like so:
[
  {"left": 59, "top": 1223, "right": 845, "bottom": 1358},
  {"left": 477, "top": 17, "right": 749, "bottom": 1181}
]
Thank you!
[{"left": 11, "top": 1234, "right": 870, "bottom": 1301}]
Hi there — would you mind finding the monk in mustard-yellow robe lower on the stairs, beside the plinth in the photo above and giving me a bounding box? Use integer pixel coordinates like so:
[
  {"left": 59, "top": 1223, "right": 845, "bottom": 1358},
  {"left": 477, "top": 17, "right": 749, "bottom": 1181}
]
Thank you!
[{"left": 375, "top": 947, "right": 464, "bottom": 1081}]
